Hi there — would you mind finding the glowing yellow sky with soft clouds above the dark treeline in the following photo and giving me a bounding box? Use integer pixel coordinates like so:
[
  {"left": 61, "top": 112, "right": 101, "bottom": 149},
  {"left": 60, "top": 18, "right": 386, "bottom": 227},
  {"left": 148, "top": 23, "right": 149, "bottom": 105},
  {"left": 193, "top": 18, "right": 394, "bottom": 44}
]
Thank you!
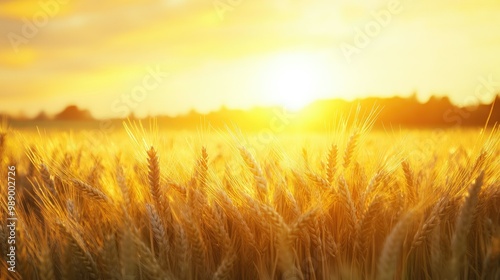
[{"left": 0, "top": 0, "right": 500, "bottom": 118}]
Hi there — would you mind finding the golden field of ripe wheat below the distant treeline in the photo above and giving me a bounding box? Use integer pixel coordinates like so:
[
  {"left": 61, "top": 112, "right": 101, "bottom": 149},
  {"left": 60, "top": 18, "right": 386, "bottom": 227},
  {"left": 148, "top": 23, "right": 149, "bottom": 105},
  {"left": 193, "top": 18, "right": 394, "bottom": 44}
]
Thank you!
[{"left": 0, "top": 123, "right": 500, "bottom": 280}]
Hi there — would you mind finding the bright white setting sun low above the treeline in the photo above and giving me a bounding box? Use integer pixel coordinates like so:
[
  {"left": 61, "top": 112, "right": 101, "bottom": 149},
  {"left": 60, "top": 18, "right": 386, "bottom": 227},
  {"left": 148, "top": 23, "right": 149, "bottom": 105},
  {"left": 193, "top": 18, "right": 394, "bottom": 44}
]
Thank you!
[{"left": 262, "top": 53, "right": 330, "bottom": 111}]
